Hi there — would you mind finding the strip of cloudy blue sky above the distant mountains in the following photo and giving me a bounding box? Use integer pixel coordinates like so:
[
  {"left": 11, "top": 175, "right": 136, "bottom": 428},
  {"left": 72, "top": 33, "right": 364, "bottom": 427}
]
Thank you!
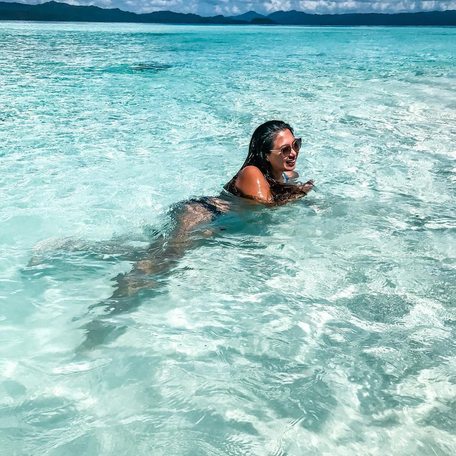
[{"left": 6, "top": 0, "right": 456, "bottom": 16}]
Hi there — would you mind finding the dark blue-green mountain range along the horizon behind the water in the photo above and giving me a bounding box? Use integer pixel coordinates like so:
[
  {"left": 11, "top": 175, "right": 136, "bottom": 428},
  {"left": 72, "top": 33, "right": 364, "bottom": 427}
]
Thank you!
[{"left": 0, "top": 1, "right": 456, "bottom": 26}]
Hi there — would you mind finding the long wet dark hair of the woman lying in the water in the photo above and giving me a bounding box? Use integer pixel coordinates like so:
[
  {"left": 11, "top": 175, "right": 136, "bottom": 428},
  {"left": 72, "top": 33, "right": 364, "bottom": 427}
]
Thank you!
[{"left": 224, "top": 120, "right": 305, "bottom": 202}]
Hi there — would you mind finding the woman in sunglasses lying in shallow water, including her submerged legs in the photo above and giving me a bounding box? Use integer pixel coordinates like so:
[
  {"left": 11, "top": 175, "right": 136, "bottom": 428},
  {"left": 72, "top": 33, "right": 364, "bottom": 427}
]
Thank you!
[{"left": 79, "top": 120, "right": 313, "bottom": 348}]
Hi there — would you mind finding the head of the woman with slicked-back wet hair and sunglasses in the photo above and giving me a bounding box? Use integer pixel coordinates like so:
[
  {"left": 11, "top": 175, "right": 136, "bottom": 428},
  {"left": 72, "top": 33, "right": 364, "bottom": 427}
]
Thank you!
[{"left": 242, "top": 120, "right": 300, "bottom": 179}]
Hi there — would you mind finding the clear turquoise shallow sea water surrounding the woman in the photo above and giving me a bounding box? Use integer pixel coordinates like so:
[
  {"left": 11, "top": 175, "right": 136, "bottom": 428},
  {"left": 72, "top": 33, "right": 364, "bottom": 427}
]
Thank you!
[{"left": 0, "top": 23, "right": 456, "bottom": 455}]
